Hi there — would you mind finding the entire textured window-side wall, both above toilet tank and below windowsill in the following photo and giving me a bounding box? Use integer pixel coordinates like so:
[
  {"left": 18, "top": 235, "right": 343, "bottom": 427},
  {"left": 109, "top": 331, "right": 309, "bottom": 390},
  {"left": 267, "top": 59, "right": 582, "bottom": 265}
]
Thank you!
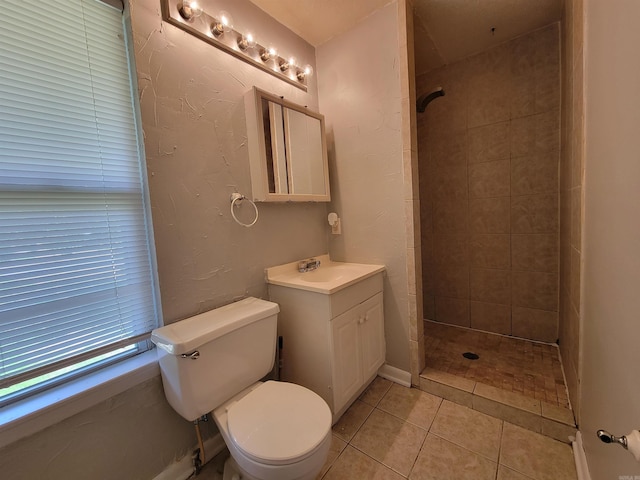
[{"left": 0, "top": 0, "right": 328, "bottom": 480}]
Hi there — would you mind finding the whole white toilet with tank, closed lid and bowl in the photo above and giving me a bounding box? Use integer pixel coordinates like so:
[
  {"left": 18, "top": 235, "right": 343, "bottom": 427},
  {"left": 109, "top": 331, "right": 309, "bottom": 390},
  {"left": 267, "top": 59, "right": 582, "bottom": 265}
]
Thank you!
[{"left": 151, "top": 298, "right": 331, "bottom": 480}]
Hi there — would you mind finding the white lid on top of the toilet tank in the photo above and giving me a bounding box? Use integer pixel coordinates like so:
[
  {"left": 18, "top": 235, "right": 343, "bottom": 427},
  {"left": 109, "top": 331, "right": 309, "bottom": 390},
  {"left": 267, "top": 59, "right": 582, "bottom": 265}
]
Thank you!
[{"left": 151, "top": 297, "right": 280, "bottom": 355}]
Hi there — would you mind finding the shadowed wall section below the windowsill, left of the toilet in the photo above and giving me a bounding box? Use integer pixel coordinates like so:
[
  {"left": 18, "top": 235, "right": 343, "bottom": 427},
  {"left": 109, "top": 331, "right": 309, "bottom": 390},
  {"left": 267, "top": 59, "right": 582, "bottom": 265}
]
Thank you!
[{"left": 0, "top": 377, "right": 215, "bottom": 480}]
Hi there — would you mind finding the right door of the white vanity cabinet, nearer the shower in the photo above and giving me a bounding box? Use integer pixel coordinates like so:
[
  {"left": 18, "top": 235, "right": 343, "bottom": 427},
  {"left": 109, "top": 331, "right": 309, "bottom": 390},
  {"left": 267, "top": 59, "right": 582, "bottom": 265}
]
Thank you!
[{"left": 358, "top": 293, "right": 386, "bottom": 381}]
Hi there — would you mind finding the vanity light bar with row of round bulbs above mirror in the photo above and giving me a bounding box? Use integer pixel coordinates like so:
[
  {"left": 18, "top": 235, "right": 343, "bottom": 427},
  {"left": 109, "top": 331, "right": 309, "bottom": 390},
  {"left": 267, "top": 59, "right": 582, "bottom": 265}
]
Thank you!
[{"left": 160, "top": 0, "right": 313, "bottom": 92}]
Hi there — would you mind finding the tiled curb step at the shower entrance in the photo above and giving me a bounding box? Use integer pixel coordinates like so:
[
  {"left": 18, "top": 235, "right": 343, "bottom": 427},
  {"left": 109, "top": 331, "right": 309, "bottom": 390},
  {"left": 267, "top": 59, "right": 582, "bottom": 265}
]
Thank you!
[{"left": 419, "top": 368, "right": 577, "bottom": 444}]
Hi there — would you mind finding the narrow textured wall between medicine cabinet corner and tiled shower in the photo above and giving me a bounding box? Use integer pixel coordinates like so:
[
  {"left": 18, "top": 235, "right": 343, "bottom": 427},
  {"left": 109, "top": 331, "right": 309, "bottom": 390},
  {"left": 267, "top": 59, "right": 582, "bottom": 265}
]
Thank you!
[{"left": 317, "top": 2, "right": 410, "bottom": 371}]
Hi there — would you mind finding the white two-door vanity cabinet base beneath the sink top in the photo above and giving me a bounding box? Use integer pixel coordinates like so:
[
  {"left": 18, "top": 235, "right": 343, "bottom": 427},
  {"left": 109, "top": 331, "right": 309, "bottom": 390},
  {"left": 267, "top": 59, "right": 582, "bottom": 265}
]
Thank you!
[{"left": 269, "top": 267, "right": 386, "bottom": 423}]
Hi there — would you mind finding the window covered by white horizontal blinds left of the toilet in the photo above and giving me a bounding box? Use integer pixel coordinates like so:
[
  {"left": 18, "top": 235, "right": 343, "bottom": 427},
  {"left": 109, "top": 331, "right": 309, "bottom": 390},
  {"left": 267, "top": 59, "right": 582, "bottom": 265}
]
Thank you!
[{"left": 0, "top": 0, "right": 158, "bottom": 405}]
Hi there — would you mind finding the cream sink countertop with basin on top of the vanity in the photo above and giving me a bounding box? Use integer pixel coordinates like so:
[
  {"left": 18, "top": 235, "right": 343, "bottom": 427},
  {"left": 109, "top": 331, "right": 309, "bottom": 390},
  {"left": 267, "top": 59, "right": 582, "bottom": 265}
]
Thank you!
[{"left": 266, "top": 255, "right": 384, "bottom": 294}]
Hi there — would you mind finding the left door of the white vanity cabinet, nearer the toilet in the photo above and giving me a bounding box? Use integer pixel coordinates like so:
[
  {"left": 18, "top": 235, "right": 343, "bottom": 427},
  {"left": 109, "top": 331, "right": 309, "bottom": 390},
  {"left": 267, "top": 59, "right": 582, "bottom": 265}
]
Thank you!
[{"left": 331, "top": 307, "right": 364, "bottom": 412}]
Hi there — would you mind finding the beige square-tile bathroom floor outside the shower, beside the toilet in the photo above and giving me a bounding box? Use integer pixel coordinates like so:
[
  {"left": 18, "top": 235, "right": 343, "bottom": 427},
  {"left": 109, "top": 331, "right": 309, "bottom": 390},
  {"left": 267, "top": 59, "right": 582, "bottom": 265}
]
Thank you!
[{"left": 198, "top": 377, "right": 577, "bottom": 480}]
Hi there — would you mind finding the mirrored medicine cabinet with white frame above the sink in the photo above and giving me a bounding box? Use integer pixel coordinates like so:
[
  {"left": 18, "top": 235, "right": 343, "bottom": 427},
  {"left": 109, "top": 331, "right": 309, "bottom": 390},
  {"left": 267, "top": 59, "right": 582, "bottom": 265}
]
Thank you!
[{"left": 245, "top": 87, "right": 331, "bottom": 202}]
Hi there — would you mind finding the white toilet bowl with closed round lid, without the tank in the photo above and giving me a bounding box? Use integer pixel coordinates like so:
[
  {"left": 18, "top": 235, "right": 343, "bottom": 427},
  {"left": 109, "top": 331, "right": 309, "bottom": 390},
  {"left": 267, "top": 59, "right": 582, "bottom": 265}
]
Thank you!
[{"left": 213, "top": 381, "right": 331, "bottom": 480}]
